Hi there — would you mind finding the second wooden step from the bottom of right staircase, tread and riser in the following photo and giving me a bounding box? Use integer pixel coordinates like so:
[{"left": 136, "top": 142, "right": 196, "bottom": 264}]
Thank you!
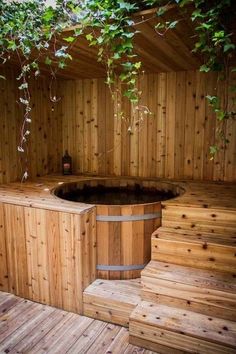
[{"left": 141, "top": 261, "right": 236, "bottom": 320}]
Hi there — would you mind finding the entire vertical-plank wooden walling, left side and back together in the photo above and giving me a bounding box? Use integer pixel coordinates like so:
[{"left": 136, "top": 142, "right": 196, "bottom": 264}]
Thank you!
[{"left": 0, "top": 69, "right": 236, "bottom": 183}]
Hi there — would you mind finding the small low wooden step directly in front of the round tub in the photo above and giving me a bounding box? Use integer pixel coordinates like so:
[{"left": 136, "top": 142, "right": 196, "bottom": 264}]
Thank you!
[{"left": 83, "top": 278, "right": 141, "bottom": 327}]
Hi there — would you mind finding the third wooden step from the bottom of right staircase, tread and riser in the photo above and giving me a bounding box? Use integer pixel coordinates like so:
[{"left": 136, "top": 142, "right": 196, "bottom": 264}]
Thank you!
[{"left": 151, "top": 227, "right": 236, "bottom": 274}]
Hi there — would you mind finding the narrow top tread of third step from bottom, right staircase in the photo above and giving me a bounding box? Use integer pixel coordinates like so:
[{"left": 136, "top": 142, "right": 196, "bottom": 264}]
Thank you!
[{"left": 152, "top": 226, "right": 236, "bottom": 246}]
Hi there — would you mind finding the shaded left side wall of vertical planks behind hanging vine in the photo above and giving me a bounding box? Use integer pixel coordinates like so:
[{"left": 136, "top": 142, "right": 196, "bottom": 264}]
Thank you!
[{"left": 0, "top": 68, "right": 62, "bottom": 183}]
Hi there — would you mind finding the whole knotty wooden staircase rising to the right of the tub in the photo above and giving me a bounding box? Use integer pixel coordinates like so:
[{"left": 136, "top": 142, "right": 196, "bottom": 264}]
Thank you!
[{"left": 129, "top": 203, "right": 236, "bottom": 354}]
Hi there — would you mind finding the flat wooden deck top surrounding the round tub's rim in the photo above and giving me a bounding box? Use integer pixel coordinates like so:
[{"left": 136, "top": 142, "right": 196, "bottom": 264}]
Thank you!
[{"left": 0, "top": 175, "right": 236, "bottom": 214}]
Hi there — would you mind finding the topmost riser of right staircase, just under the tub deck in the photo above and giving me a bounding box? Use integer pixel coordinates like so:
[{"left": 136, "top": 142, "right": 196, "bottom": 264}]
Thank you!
[{"left": 162, "top": 202, "right": 236, "bottom": 236}]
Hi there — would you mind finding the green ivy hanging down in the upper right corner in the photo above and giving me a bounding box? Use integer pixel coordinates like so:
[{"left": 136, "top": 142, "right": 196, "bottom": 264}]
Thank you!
[{"left": 146, "top": 0, "right": 236, "bottom": 158}]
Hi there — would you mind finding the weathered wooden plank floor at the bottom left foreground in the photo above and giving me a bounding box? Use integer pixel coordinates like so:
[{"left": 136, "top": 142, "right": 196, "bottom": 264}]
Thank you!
[{"left": 0, "top": 292, "right": 157, "bottom": 354}]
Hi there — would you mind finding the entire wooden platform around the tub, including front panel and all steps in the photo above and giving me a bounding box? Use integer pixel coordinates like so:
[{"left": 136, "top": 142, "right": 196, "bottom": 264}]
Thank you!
[{"left": 0, "top": 176, "right": 236, "bottom": 354}]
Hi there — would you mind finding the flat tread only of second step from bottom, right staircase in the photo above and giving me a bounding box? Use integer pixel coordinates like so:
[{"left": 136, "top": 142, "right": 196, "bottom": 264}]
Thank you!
[{"left": 141, "top": 261, "right": 236, "bottom": 294}]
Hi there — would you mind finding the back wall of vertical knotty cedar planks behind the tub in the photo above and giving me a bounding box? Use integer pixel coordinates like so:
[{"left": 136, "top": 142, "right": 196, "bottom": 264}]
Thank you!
[{"left": 61, "top": 71, "right": 236, "bottom": 181}]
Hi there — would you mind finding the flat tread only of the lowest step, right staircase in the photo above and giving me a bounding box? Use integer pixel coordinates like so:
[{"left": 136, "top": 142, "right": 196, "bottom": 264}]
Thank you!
[{"left": 130, "top": 301, "right": 236, "bottom": 348}]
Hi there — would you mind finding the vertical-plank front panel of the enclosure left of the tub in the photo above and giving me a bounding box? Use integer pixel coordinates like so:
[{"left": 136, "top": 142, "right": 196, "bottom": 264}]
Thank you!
[{"left": 0, "top": 204, "right": 96, "bottom": 313}]
